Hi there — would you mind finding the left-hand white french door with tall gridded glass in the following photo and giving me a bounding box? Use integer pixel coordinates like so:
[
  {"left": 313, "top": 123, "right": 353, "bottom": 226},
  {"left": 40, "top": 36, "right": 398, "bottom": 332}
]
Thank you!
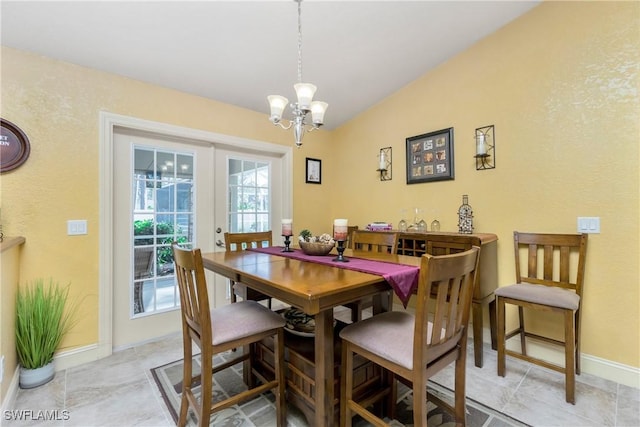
[{"left": 113, "top": 129, "right": 214, "bottom": 348}]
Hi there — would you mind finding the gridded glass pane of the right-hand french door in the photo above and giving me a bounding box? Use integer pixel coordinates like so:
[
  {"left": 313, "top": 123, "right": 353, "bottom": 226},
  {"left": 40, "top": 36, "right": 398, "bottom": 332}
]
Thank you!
[{"left": 228, "top": 159, "right": 271, "bottom": 233}]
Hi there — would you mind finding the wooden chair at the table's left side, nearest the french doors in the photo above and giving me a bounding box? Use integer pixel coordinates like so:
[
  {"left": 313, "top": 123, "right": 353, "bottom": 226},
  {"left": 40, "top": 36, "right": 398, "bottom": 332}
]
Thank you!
[{"left": 172, "top": 243, "right": 286, "bottom": 426}]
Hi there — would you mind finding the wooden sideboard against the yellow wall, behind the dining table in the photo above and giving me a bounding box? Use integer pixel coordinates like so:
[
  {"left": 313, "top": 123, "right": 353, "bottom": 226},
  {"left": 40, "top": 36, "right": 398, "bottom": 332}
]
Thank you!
[{"left": 358, "top": 231, "right": 498, "bottom": 368}]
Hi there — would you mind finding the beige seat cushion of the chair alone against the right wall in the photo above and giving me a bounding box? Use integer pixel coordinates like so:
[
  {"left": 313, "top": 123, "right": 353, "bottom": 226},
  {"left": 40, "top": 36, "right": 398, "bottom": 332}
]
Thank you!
[{"left": 494, "top": 283, "right": 580, "bottom": 310}]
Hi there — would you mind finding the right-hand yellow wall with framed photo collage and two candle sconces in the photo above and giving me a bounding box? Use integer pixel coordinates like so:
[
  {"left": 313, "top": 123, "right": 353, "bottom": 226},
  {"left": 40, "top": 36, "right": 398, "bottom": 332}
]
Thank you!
[{"left": 332, "top": 2, "right": 640, "bottom": 367}]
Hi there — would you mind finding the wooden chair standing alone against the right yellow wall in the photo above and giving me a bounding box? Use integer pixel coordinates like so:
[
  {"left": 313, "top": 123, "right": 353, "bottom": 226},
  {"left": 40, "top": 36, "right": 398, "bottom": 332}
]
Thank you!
[{"left": 495, "top": 231, "right": 588, "bottom": 404}]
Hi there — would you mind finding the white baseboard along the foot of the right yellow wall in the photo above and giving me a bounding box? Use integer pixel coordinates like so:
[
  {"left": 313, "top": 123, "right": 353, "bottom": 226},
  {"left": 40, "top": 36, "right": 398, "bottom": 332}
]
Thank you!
[{"left": 482, "top": 328, "right": 640, "bottom": 389}]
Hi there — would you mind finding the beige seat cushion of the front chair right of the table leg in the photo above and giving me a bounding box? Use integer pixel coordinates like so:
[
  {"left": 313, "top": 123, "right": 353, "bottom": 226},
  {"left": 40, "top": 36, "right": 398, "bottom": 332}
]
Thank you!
[{"left": 340, "top": 311, "right": 445, "bottom": 369}]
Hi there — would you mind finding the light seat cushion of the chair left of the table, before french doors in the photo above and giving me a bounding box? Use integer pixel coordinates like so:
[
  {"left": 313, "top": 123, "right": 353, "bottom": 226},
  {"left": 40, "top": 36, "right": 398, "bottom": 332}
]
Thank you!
[{"left": 211, "top": 300, "right": 285, "bottom": 345}]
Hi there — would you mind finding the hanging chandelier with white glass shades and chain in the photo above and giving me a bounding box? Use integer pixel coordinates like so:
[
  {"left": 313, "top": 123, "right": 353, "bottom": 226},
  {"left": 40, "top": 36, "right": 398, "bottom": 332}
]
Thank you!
[{"left": 267, "top": 0, "right": 329, "bottom": 148}]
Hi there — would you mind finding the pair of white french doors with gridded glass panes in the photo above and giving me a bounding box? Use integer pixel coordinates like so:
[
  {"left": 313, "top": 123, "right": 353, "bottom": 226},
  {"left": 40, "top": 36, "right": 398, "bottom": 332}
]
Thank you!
[{"left": 112, "top": 128, "right": 290, "bottom": 348}]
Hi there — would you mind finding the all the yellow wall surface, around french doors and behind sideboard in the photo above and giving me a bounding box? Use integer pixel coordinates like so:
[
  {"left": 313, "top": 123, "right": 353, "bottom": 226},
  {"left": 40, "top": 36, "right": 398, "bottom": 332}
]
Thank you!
[{"left": 0, "top": 2, "right": 640, "bottom": 378}]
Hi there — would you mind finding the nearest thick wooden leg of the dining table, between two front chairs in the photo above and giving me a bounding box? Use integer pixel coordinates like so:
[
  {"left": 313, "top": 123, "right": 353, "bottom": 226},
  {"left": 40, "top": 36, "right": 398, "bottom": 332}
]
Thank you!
[{"left": 315, "top": 309, "right": 335, "bottom": 427}]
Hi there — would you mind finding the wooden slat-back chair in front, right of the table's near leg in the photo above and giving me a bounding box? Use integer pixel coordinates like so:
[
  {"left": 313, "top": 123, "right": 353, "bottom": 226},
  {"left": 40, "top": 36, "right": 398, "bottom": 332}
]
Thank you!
[{"left": 340, "top": 246, "right": 480, "bottom": 427}]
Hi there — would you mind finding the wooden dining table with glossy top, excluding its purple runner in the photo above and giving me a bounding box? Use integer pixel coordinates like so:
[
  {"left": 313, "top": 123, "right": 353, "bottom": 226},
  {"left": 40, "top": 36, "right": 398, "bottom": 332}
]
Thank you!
[{"left": 202, "top": 249, "right": 420, "bottom": 426}]
